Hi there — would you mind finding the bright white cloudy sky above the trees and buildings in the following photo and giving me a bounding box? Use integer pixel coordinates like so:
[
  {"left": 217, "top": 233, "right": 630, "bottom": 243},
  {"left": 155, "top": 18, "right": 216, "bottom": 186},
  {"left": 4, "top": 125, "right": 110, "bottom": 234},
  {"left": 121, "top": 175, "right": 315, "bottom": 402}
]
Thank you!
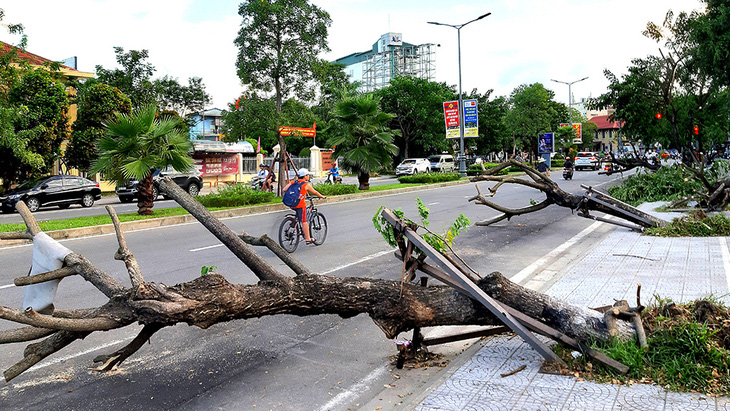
[{"left": 0, "top": 0, "right": 702, "bottom": 108}]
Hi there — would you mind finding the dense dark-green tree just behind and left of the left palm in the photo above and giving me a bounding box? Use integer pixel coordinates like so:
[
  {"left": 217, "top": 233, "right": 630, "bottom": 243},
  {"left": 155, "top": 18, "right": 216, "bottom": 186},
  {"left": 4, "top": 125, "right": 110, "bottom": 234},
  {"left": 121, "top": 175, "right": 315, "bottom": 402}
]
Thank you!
[{"left": 64, "top": 81, "right": 132, "bottom": 172}]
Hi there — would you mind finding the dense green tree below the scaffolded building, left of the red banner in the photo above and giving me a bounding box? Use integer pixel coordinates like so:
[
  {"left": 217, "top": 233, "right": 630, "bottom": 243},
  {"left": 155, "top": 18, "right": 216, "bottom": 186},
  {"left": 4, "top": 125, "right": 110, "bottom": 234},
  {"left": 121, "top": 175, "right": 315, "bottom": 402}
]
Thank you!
[{"left": 376, "top": 76, "right": 455, "bottom": 158}]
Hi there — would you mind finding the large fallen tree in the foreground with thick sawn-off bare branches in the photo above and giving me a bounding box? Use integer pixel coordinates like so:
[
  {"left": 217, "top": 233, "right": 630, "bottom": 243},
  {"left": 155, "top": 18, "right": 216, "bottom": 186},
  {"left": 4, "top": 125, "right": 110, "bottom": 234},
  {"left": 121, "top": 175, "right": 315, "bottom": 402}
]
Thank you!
[{"left": 0, "top": 179, "right": 641, "bottom": 381}]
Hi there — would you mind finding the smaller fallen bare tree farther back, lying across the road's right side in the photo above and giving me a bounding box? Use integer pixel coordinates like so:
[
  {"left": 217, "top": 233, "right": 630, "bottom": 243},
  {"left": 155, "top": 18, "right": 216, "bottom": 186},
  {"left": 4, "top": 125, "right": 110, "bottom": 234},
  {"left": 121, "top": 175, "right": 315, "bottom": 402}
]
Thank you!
[{"left": 469, "top": 159, "right": 666, "bottom": 230}]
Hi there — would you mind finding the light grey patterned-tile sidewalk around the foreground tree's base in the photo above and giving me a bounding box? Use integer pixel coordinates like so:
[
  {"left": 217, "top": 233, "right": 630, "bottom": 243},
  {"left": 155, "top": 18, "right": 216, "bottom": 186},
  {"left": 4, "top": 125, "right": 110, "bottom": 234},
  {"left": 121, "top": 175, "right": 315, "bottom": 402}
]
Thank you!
[{"left": 415, "top": 228, "right": 730, "bottom": 411}]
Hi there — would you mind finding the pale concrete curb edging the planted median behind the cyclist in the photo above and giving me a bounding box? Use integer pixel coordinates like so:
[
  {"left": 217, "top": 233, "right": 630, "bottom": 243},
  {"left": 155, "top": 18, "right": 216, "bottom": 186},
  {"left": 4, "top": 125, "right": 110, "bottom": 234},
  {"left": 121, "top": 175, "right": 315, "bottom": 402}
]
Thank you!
[{"left": 3, "top": 180, "right": 470, "bottom": 247}]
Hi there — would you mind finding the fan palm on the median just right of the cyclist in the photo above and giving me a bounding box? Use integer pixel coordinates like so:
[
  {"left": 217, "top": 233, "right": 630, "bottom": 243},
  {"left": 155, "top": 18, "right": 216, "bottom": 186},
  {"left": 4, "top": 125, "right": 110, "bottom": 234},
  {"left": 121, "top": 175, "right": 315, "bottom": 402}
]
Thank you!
[{"left": 329, "top": 94, "right": 398, "bottom": 190}]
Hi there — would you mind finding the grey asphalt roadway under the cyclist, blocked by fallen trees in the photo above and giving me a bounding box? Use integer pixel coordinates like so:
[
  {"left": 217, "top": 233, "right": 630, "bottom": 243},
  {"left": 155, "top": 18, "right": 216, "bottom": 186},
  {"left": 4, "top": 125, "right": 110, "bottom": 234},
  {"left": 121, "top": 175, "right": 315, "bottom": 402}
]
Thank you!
[{"left": 0, "top": 171, "right": 616, "bottom": 410}]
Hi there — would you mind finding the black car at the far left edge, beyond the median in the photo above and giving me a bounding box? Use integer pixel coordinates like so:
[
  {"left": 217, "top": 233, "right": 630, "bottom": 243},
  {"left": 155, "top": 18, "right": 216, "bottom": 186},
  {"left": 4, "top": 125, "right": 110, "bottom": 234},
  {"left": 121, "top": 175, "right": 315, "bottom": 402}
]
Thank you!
[{"left": 0, "top": 176, "right": 101, "bottom": 213}]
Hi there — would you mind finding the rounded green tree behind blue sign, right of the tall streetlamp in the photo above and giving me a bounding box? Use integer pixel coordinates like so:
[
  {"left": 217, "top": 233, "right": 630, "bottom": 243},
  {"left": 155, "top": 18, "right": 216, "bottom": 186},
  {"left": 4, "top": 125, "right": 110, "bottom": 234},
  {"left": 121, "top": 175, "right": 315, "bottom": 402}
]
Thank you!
[{"left": 505, "top": 83, "right": 556, "bottom": 154}]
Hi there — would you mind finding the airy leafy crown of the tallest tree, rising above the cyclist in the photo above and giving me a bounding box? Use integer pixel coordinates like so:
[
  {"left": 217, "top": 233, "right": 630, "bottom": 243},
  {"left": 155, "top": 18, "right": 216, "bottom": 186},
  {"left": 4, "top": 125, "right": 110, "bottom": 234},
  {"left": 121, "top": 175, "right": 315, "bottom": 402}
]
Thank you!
[{"left": 234, "top": 0, "right": 332, "bottom": 112}]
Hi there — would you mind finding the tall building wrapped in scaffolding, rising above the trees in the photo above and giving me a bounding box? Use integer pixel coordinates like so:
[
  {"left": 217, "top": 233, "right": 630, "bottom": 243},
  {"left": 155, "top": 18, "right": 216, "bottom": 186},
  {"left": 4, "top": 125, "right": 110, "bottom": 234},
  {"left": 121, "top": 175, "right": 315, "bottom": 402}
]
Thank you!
[{"left": 334, "top": 33, "right": 437, "bottom": 92}]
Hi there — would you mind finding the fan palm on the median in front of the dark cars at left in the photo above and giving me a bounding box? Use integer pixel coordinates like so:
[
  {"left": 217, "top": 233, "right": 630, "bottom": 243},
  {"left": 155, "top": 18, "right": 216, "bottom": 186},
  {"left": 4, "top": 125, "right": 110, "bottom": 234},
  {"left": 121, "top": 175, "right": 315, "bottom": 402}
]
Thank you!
[{"left": 91, "top": 105, "right": 193, "bottom": 215}]
